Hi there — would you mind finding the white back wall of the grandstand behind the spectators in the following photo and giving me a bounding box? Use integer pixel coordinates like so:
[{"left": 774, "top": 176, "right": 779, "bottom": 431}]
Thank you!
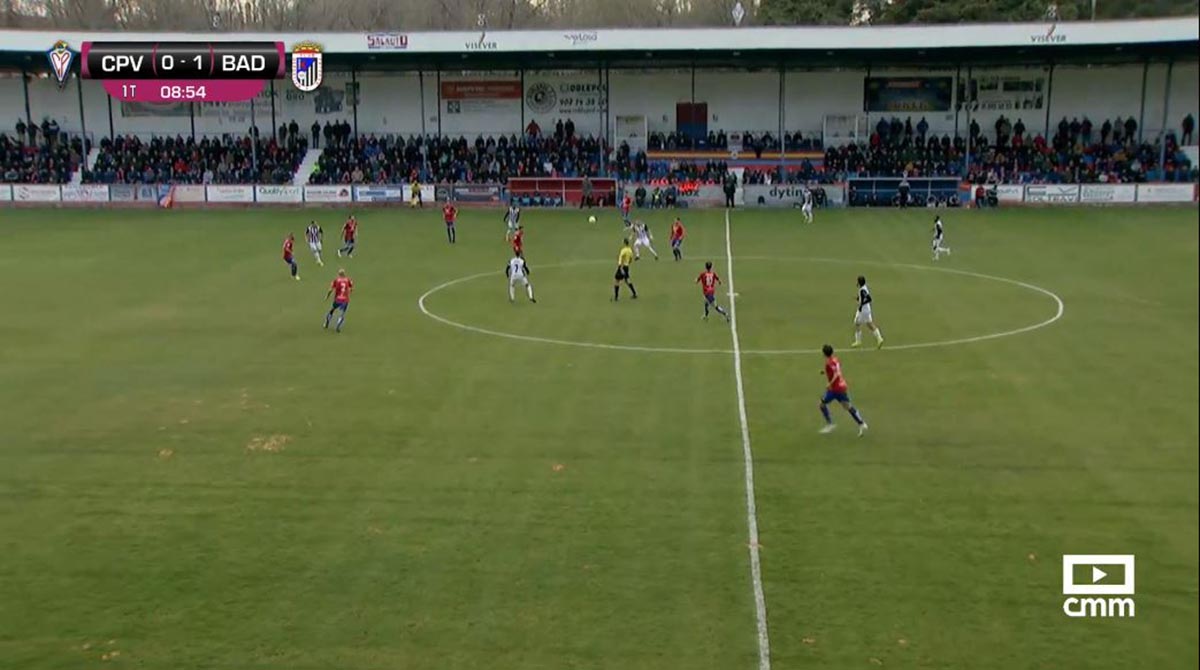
[{"left": 0, "top": 62, "right": 1200, "bottom": 145}]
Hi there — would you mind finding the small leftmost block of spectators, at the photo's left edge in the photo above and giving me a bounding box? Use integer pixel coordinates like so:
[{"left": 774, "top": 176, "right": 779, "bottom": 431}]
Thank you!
[{"left": 0, "top": 119, "right": 90, "bottom": 184}]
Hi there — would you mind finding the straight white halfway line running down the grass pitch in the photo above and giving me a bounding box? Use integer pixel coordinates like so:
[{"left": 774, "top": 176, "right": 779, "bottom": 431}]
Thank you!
[{"left": 725, "top": 210, "right": 770, "bottom": 670}]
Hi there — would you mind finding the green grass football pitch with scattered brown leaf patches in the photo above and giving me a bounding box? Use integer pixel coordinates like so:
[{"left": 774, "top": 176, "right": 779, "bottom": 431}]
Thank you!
[{"left": 0, "top": 208, "right": 1200, "bottom": 670}]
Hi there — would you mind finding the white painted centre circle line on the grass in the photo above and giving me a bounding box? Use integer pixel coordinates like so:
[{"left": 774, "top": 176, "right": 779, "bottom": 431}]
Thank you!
[{"left": 416, "top": 256, "right": 1064, "bottom": 355}]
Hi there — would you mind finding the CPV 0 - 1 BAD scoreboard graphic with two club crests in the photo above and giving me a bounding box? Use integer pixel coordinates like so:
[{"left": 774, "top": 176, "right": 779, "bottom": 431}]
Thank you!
[{"left": 46, "top": 40, "right": 323, "bottom": 103}]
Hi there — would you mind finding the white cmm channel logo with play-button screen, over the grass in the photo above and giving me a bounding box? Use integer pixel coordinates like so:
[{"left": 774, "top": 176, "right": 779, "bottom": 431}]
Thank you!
[{"left": 1062, "top": 554, "right": 1134, "bottom": 618}]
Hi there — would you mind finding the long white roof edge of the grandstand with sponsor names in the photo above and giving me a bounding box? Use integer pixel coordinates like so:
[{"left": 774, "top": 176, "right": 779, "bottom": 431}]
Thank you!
[{"left": 0, "top": 17, "right": 1200, "bottom": 70}]
